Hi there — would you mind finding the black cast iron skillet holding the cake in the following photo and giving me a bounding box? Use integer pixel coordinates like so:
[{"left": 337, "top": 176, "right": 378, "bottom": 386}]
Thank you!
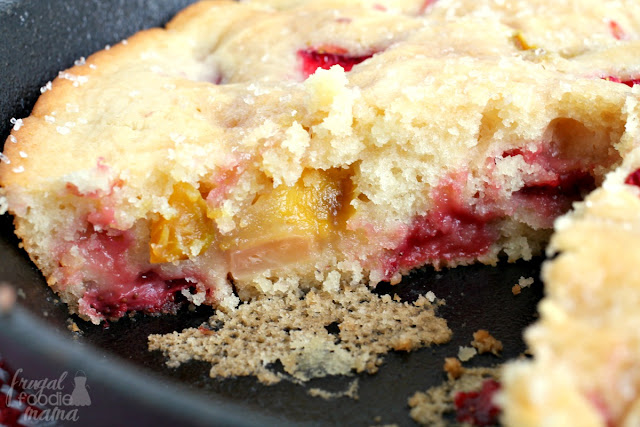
[{"left": 0, "top": 0, "right": 542, "bottom": 426}]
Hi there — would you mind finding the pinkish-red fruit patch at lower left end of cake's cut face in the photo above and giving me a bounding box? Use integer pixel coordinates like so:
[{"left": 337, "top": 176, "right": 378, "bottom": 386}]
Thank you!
[{"left": 77, "top": 227, "right": 192, "bottom": 319}]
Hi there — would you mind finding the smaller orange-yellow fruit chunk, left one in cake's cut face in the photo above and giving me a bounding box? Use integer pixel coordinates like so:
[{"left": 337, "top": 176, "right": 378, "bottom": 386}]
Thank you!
[{"left": 150, "top": 182, "right": 216, "bottom": 263}]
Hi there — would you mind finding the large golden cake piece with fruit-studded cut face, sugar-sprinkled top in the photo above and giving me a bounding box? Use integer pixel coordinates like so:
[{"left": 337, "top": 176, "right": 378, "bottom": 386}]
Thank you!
[{"left": 0, "top": 1, "right": 637, "bottom": 323}]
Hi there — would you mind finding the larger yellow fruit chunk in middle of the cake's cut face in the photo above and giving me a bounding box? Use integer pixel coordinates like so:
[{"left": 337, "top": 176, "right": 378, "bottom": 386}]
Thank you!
[{"left": 222, "top": 170, "right": 353, "bottom": 276}]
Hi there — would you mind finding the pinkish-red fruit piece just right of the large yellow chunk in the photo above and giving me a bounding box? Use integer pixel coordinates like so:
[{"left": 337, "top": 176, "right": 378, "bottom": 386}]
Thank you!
[{"left": 385, "top": 181, "right": 499, "bottom": 279}]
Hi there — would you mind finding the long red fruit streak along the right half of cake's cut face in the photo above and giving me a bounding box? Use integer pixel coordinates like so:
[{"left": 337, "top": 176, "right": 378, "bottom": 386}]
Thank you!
[{"left": 384, "top": 144, "right": 595, "bottom": 280}]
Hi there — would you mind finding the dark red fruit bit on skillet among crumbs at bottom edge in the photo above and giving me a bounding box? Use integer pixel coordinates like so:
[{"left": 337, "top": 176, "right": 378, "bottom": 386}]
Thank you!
[{"left": 454, "top": 379, "right": 500, "bottom": 426}]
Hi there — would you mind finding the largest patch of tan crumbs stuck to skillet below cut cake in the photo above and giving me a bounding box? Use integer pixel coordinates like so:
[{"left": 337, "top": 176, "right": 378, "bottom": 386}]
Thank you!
[{"left": 149, "top": 286, "right": 451, "bottom": 384}]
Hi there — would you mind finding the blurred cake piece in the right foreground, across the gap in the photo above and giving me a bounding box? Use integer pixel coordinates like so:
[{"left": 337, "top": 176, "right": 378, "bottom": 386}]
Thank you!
[{"left": 500, "top": 145, "right": 640, "bottom": 426}]
